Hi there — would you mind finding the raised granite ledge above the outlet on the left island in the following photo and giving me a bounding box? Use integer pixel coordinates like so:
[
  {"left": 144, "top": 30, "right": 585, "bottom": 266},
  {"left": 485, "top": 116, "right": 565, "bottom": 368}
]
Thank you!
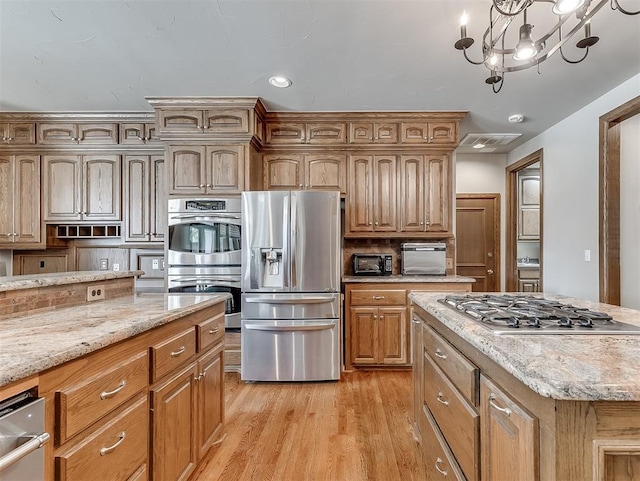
[{"left": 0, "top": 271, "right": 144, "bottom": 292}]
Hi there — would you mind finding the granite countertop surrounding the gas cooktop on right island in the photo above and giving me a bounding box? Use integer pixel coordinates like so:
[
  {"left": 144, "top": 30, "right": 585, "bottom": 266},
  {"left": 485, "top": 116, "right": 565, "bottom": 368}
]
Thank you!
[{"left": 409, "top": 292, "right": 640, "bottom": 401}]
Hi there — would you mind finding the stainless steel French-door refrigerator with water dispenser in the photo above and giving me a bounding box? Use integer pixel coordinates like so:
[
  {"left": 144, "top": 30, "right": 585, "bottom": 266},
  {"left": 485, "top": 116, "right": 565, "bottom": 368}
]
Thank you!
[{"left": 241, "top": 191, "right": 342, "bottom": 381}]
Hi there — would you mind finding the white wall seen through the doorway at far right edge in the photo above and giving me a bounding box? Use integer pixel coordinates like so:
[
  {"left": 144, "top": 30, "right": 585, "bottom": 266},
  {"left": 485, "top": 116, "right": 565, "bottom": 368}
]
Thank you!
[{"left": 620, "top": 115, "right": 640, "bottom": 309}]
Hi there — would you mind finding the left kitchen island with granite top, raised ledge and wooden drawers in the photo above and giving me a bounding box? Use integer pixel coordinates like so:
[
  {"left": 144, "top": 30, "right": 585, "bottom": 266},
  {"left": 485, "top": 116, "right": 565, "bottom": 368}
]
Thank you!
[{"left": 0, "top": 272, "right": 228, "bottom": 481}]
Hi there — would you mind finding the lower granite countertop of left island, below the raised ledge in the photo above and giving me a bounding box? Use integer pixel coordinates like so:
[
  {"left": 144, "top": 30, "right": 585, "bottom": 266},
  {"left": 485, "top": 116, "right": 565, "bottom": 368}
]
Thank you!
[{"left": 0, "top": 294, "right": 229, "bottom": 386}]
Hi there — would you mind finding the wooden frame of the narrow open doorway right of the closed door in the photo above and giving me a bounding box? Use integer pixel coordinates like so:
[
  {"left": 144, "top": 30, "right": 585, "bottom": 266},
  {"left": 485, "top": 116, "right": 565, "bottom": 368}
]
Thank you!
[{"left": 505, "top": 149, "right": 544, "bottom": 292}]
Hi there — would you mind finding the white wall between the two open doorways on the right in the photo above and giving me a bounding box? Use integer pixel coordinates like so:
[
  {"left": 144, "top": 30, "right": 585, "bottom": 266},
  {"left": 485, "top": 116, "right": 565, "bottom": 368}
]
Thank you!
[{"left": 507, "top": 74, "right": 640, "bottom": 301}]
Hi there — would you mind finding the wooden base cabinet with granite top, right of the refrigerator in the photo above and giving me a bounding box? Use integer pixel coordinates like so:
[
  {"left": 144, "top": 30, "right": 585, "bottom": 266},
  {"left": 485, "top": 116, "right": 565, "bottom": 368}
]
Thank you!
[{"left": 342, "top": 275, "right": 475, "bottom": 370}]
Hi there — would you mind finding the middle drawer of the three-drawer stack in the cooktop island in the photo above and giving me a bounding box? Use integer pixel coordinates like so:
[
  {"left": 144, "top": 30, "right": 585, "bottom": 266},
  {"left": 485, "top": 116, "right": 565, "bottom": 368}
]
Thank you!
[{"left": 424, "top": 353, "right": 480, "bottom": 481}]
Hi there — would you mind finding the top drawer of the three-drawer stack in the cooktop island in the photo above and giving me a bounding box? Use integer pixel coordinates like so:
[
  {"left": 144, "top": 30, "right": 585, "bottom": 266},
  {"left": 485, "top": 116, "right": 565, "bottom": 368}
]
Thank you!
[{"left": 422, "top": 324, "right": 480, "bottom": 406}]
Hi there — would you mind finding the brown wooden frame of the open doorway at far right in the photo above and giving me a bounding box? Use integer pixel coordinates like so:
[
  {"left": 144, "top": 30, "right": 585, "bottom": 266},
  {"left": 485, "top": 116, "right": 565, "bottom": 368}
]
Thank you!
[{"left": 599, "top": 96, "right": 640, "bottom": 306}]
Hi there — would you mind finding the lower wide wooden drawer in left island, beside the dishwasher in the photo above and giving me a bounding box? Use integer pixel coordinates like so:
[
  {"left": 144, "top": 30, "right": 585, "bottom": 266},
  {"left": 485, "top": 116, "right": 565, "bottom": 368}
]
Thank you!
[{"left": 55, "top": 393, "right": 149, "bottom": 481}]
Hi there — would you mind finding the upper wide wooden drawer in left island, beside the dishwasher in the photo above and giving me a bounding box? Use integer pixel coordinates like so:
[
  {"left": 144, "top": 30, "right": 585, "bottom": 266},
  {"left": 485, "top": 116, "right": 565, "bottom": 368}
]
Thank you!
[{"left": 56, "top": 352, "right": 149, "bottom": 443}]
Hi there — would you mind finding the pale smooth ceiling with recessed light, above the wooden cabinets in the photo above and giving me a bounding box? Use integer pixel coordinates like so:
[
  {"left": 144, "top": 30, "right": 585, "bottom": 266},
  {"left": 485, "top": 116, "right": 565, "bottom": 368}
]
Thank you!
[{"left": 0, "top": 0, "right": 640, "bottom": 152}]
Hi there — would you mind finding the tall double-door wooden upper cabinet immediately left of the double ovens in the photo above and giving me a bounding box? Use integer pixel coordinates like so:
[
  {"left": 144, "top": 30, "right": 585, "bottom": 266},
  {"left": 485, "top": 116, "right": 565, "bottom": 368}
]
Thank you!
[{"left": 123, "top": 155, "right": 167, "bottom": 242}]
